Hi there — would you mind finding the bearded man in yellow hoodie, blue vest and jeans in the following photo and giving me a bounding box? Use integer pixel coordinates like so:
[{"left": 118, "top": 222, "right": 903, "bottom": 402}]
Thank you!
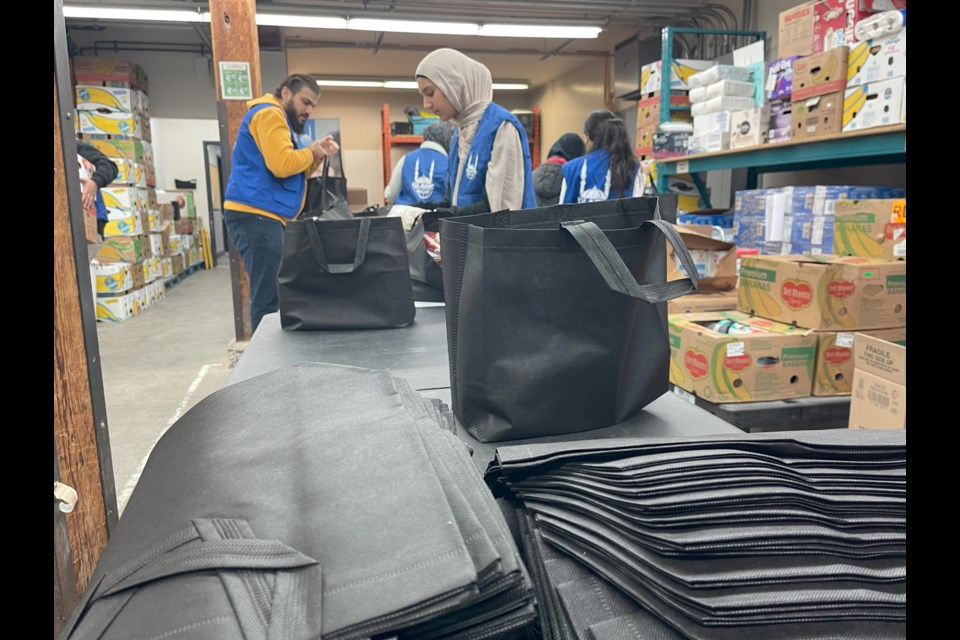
[{"left": 223, "top": 74, "right": 339, "bottom": 331}]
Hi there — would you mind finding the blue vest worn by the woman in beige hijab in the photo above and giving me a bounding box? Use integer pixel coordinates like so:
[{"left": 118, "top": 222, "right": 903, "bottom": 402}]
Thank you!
[{"left": 448, "top": 102, "right": 537, "bottom": 209}]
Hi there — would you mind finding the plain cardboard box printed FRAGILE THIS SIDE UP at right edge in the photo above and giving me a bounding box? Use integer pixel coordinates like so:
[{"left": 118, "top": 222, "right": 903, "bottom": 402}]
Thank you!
[{"left": 849, "top": 333, "right": 907, "bottom": 429}]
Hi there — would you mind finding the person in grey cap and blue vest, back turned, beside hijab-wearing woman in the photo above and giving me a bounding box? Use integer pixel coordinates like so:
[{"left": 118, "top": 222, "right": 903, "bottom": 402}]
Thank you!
[{"left": 383, "top": 120, "right": 454, "bottom": 206}]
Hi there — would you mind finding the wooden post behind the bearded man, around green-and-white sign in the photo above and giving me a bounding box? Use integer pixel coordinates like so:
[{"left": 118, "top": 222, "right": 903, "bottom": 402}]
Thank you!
[{"left": 210, "top": 0, "right": 262, "bottom": 341}]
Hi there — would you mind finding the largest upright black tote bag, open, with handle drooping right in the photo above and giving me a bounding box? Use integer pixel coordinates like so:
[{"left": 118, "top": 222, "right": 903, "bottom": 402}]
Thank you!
[{"left": 440, "top": 196, "right": 698, "bottom": 442}]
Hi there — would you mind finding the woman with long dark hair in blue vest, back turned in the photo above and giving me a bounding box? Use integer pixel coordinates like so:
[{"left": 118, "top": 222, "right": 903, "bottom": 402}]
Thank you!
[{"left": 560, "top": 109, "right": 643, "bottom": 204}]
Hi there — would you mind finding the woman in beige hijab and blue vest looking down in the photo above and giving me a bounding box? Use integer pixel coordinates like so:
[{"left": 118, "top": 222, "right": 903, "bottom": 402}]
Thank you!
[{"left": 416, "top": 49, "right": 537, "bottom": 215}]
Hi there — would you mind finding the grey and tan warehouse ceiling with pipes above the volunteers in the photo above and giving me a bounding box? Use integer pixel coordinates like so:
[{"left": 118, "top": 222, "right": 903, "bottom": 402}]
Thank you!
[{"left": 64, "top": 0, "right": 751, "bottom": 88}]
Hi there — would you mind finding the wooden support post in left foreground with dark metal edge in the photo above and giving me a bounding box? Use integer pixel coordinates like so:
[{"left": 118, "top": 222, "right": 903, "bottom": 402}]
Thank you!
[{"left": 53, "top": 0, "right": 117, "bottom": 593}]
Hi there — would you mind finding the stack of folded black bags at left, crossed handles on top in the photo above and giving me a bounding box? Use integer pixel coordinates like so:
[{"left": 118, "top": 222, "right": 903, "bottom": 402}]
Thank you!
[{"left": 63, "top": 363, "right": 536, "bottom": 640}]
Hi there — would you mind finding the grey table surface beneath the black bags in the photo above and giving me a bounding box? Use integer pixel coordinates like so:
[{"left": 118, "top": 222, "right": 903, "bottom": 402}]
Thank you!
[{"left": 227, "top": 307, "right": 742, "bottom": 471}]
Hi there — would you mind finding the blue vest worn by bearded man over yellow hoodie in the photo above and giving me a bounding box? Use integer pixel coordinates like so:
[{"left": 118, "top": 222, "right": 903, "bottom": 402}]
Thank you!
[{"left": 224, "top": 103, "right": 307, "bottom": 219}]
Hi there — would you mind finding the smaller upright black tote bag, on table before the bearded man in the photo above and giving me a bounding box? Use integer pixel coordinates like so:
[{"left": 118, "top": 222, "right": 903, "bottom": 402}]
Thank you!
[{"left": 277, "top": 217, "right": 416, "bottom": 331}]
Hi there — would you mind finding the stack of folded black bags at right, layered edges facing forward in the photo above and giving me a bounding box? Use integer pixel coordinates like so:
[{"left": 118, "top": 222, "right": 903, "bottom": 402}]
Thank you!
[{"left": 487, "top": 430, "right": 906, "bottom": 640}]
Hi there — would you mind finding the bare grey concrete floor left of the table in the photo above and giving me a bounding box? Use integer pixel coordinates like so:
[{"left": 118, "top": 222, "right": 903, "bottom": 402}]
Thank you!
[{"left": 97, "top": 255, "right": 234, "bottom": 515}]
